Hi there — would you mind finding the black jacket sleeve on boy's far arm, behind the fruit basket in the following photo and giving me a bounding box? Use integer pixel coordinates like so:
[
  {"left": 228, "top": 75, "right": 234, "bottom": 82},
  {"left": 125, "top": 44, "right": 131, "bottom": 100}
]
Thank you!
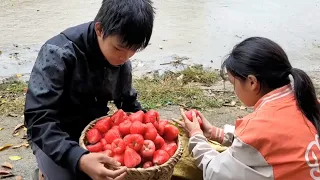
[{"left": 114, "top": 61, "right": 145, "bottom": 112}]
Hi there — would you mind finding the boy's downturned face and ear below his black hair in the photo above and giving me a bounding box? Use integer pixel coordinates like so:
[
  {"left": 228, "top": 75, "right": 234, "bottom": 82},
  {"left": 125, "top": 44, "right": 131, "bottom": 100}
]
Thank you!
[{"left": 95, "top": 23, "right": 136, "bottom": 66}]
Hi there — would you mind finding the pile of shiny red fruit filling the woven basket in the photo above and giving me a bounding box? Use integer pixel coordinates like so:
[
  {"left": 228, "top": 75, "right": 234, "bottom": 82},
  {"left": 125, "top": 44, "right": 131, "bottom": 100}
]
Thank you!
[{"left": 86, "top": 109, "right": 179, "bottom": 168}]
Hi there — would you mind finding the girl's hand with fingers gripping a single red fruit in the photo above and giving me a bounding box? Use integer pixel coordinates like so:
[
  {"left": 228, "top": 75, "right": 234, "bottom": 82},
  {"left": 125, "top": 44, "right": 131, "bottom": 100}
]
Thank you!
[{"left": 176, "top": 108, "right": 203, "bottom": 136}]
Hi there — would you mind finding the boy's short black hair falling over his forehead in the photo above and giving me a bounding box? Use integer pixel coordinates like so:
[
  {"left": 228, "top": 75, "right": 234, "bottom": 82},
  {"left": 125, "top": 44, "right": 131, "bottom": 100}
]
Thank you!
[{"left": 94, "top": 0, "right": 155, "bottom": 51}]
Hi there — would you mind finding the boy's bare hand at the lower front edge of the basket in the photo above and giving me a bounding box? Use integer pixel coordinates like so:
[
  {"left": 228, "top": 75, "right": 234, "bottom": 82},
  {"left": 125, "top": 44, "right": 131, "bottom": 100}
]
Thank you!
[{"left": 79, "top": 153, "right": 127, "bottom": 180}]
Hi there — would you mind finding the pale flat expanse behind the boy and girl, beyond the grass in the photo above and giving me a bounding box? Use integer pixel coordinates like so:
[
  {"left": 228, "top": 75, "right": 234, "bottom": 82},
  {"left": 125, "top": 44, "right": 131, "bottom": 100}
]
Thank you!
[{"left": 0, "top": 0, "right": 320, "bottom": 77}]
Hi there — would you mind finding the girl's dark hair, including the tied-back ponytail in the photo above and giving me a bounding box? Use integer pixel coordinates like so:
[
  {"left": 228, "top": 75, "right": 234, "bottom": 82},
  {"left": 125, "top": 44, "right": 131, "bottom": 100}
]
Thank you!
[{"left": 221, "top": 37, "right": 320, "bottom": 134}]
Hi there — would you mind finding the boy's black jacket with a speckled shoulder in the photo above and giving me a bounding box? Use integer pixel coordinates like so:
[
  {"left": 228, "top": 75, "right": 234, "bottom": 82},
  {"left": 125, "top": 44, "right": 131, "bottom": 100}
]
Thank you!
[{"left": 24, "top": 22, "right": 141, "bottom": 174}]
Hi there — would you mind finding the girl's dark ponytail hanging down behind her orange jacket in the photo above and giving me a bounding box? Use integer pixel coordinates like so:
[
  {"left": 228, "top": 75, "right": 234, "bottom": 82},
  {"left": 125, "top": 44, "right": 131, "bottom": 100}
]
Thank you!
[{"left": 291, "top": 68, "right": 320, "bottom": 134}]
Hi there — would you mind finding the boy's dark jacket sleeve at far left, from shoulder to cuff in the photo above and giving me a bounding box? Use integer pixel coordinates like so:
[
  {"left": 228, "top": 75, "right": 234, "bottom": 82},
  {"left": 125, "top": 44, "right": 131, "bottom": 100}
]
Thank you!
[{"left": 24, "top": 44, "right": 88, "bottom": 173}]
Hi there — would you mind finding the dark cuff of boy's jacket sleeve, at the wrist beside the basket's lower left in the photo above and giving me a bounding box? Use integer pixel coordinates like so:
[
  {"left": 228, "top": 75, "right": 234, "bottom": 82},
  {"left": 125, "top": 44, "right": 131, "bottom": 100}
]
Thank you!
[{"left": 64, "top": 146, "right": 89, "bottom": 174}]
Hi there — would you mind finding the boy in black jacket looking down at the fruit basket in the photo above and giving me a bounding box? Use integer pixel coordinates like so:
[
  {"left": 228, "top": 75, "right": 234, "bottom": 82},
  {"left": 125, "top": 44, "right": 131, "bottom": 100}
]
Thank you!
[{"left": 24, "top": 0, "right": 154, "bottom": 180}]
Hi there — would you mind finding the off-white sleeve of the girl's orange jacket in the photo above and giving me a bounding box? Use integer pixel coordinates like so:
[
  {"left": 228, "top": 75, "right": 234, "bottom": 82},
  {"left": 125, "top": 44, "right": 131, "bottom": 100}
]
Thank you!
[{"left": 189, "top": 132, "right": 274, "bottom": 180}]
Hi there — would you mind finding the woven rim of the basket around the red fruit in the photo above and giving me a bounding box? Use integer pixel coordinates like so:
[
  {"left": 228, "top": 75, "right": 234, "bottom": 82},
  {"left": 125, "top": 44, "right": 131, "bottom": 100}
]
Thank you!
[{"left": 79, "top": 112, "right": 183, "bottom": 171}]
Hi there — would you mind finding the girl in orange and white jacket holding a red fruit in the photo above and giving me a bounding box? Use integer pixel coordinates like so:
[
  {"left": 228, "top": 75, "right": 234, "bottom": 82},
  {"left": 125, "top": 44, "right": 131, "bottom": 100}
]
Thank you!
[{"left": 179, "top": 37, "right": 320, "bottom": 180}]
